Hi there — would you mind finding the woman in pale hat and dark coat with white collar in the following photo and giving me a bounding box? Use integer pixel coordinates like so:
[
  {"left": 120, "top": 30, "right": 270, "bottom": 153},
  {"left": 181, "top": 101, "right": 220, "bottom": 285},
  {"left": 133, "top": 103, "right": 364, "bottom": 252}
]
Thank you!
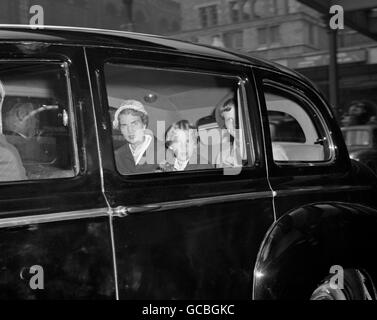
[{"left": 113, "top": 100, "right": 165, "bottom": 174}]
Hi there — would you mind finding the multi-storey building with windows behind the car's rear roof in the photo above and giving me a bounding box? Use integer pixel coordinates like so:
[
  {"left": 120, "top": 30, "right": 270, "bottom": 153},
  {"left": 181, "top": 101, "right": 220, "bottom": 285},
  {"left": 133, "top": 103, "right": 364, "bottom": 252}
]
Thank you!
[{"left": 173, "top": 0, "right": 377, "bottom": 115}]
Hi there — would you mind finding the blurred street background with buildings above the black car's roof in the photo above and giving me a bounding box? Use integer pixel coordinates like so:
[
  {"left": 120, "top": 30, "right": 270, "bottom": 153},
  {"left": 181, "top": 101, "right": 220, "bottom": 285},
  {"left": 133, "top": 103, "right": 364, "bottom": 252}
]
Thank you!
[{"left": 0, "top": 0, "right": 377, "bottom": 126}]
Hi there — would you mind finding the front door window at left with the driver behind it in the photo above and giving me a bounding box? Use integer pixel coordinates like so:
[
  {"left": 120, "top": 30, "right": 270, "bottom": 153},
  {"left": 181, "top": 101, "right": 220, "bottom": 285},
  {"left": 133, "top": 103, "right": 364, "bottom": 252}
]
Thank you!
[{"left": 0, "top": 61, "right": 78, "bottom": 181}]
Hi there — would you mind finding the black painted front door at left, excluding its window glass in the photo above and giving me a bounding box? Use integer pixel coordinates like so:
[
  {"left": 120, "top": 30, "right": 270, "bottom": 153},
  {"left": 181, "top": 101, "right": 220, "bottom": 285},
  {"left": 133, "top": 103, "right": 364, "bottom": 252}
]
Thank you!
[{"left": 0, "top": 42, "right": 115, "bottom": 299}]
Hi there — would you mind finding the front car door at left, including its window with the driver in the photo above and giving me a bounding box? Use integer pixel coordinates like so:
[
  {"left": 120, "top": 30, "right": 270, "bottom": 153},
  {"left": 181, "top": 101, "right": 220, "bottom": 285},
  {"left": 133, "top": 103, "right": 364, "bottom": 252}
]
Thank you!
[{"left": 0, "top": 42, "right": 115, "bottom": 299}]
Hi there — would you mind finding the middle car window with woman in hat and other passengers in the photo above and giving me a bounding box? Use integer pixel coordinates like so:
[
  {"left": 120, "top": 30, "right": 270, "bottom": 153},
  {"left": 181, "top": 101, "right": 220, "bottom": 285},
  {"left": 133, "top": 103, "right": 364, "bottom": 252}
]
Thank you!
[{"left": 104, "top": 63, "right": 251, "bottom": 175}]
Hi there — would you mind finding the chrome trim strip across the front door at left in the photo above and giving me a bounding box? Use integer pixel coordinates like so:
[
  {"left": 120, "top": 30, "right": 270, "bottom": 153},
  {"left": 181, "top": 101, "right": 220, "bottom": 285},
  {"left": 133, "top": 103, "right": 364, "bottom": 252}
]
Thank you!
[{"left": 0, "top": 208, "right": 109, "bottom": 228}]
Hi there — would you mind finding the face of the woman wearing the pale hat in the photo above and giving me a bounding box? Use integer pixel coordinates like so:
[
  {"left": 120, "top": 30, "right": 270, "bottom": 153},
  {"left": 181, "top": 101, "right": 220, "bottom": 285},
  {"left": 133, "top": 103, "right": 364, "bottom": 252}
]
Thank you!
[{"left": 119, "top": 114, "right": 146, "bottom": 147}]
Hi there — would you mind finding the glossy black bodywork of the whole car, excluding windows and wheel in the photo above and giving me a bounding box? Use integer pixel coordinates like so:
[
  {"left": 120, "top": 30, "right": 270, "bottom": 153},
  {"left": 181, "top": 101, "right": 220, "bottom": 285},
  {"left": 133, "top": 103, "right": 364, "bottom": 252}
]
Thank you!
[{"left": 0, "top": 27, "right": 377, "bottom": 299}]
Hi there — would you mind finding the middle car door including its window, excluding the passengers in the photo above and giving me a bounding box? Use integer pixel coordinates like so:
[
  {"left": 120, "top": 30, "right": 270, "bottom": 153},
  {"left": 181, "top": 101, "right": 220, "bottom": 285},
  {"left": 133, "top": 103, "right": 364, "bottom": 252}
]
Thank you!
[{"left": 87, "top": 48, "right": 274, "bottom": 299}]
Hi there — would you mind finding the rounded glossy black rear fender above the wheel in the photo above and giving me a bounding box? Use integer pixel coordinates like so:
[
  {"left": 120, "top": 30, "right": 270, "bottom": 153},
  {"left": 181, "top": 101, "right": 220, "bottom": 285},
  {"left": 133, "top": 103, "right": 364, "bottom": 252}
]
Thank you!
[{"left": 253, "top": 202, "right": 377, "bottom": 299}]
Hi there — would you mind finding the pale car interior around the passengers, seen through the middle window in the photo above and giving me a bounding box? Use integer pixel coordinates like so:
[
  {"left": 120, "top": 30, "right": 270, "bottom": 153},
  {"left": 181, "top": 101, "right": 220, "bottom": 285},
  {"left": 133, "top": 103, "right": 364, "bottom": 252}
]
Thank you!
[{"left": 105, "top": 63, "right": 247, "bottom": 172}]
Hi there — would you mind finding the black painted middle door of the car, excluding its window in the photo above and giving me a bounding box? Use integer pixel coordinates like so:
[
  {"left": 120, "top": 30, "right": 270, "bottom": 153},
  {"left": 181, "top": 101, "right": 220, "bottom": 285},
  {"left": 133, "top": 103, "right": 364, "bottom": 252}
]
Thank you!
[{"left": 87, "top": 48, "right": 273, "bottom": 299}]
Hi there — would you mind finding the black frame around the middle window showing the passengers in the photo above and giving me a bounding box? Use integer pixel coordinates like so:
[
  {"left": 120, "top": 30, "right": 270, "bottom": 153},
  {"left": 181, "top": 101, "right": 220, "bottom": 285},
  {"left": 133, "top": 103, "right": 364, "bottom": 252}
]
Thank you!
[{"left": 88, "top": 48, "right": 265, "bottom": 185}]
